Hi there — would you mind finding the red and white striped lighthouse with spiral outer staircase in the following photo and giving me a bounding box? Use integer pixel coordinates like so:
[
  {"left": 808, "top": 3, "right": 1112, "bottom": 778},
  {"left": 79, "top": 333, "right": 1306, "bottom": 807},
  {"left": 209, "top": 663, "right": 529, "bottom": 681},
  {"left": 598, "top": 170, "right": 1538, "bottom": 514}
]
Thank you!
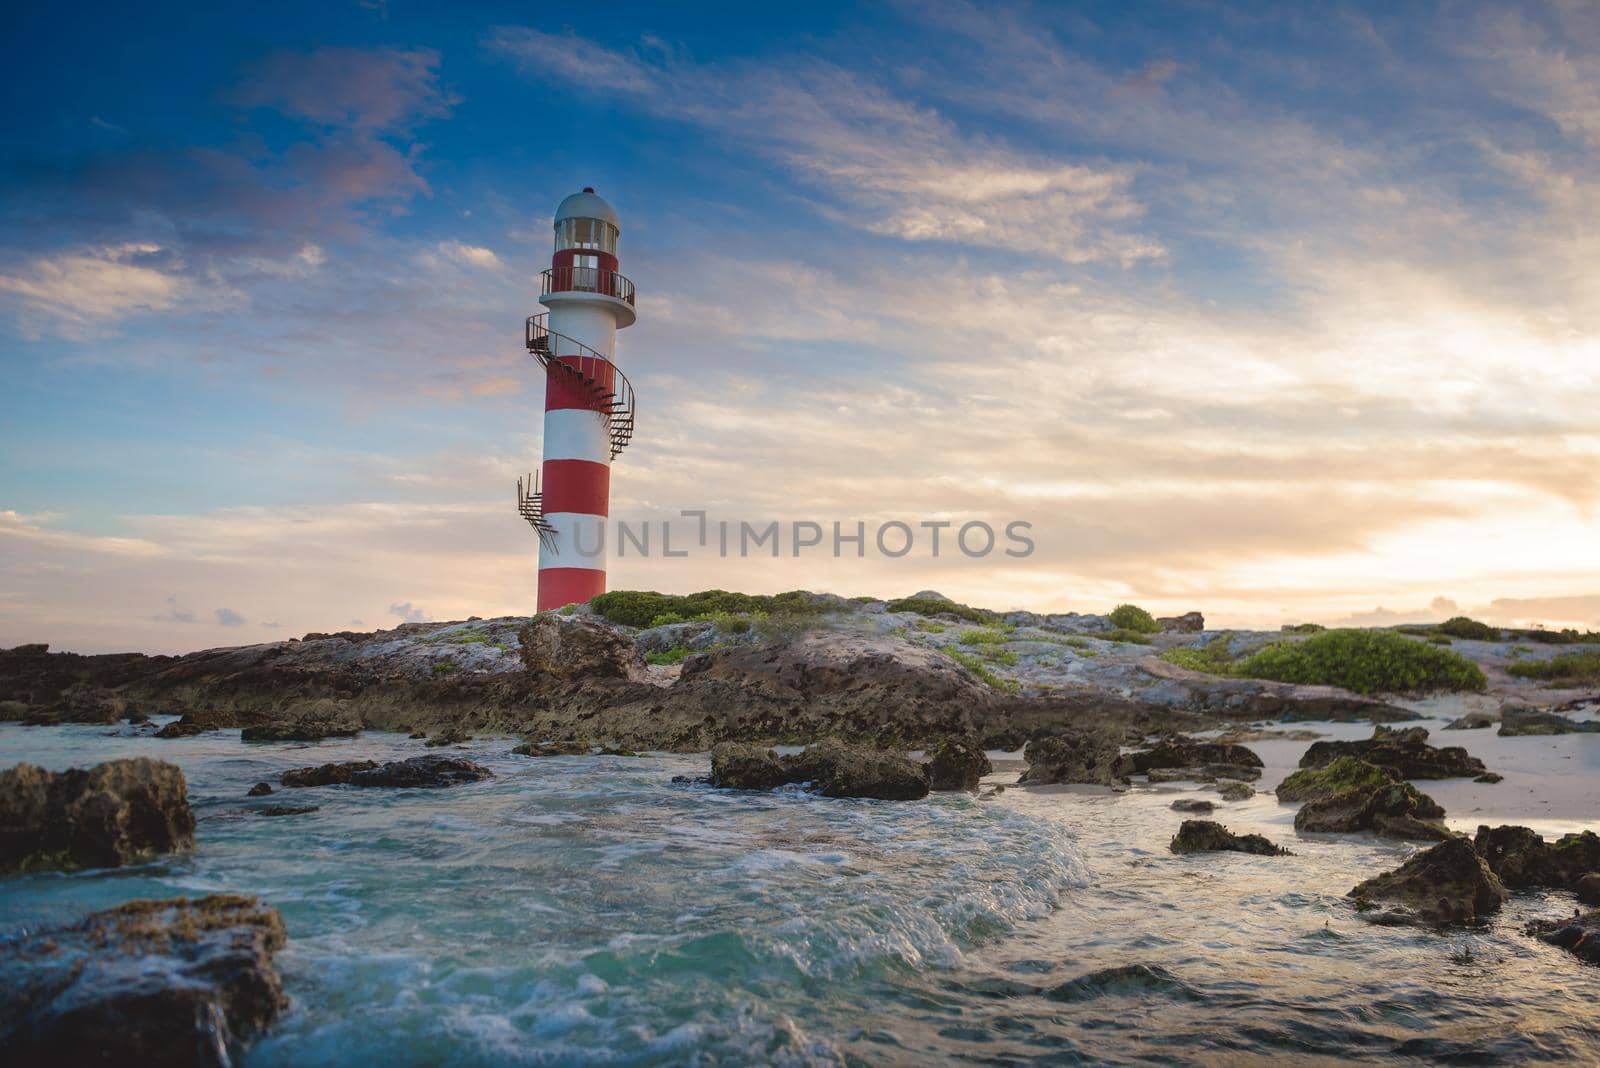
[{"left": 517, "top": 189, "right": 635, "bottom": 612}]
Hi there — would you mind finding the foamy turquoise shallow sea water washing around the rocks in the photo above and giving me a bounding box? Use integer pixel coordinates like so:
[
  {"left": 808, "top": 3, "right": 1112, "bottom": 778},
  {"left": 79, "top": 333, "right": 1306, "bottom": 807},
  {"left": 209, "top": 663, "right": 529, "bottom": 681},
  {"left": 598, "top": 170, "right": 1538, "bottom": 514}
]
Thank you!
[{"left": 0, "top": 726, "right": 1600, "bottom": 1066}]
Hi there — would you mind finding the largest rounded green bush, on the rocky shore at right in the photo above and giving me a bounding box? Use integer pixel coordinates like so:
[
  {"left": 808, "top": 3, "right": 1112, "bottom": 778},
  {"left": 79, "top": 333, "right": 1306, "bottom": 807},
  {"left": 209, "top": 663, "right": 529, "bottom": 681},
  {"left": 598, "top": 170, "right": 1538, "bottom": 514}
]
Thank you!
[{"left": 1235, "top": 630, "right": 1488, "bottom": 694}]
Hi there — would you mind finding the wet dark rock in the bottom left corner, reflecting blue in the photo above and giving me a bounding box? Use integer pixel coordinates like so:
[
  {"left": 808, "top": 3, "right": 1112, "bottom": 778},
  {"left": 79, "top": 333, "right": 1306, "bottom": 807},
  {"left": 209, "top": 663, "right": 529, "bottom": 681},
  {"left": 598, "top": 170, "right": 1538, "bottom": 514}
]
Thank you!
[{"left": 0, "top": 894, "right": 288, "bottom": 1068}]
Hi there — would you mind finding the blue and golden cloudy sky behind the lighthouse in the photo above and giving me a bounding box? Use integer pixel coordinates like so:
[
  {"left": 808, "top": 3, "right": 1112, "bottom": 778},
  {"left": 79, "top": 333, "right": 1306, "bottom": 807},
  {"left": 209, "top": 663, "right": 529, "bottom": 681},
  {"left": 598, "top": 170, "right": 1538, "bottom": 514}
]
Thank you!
[{"left": 0, "top": 0, "right": 1600, "bottom": 652}]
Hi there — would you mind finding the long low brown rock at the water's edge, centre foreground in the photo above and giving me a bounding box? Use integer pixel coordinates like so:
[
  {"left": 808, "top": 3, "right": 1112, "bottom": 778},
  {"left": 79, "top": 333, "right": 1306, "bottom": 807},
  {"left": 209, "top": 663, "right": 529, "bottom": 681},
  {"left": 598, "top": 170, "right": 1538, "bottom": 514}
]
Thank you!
[{"left": 710, "top": 739, "right": 928, "bottom": 801}]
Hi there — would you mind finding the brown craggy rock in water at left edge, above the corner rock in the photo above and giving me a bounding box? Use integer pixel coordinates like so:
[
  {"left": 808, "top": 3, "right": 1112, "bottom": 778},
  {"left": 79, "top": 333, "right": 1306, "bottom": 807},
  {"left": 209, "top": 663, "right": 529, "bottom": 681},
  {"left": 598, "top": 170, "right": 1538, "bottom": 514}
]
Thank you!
[{"left": 0, "top": 756, "right": 195, "bottom": 871}]
